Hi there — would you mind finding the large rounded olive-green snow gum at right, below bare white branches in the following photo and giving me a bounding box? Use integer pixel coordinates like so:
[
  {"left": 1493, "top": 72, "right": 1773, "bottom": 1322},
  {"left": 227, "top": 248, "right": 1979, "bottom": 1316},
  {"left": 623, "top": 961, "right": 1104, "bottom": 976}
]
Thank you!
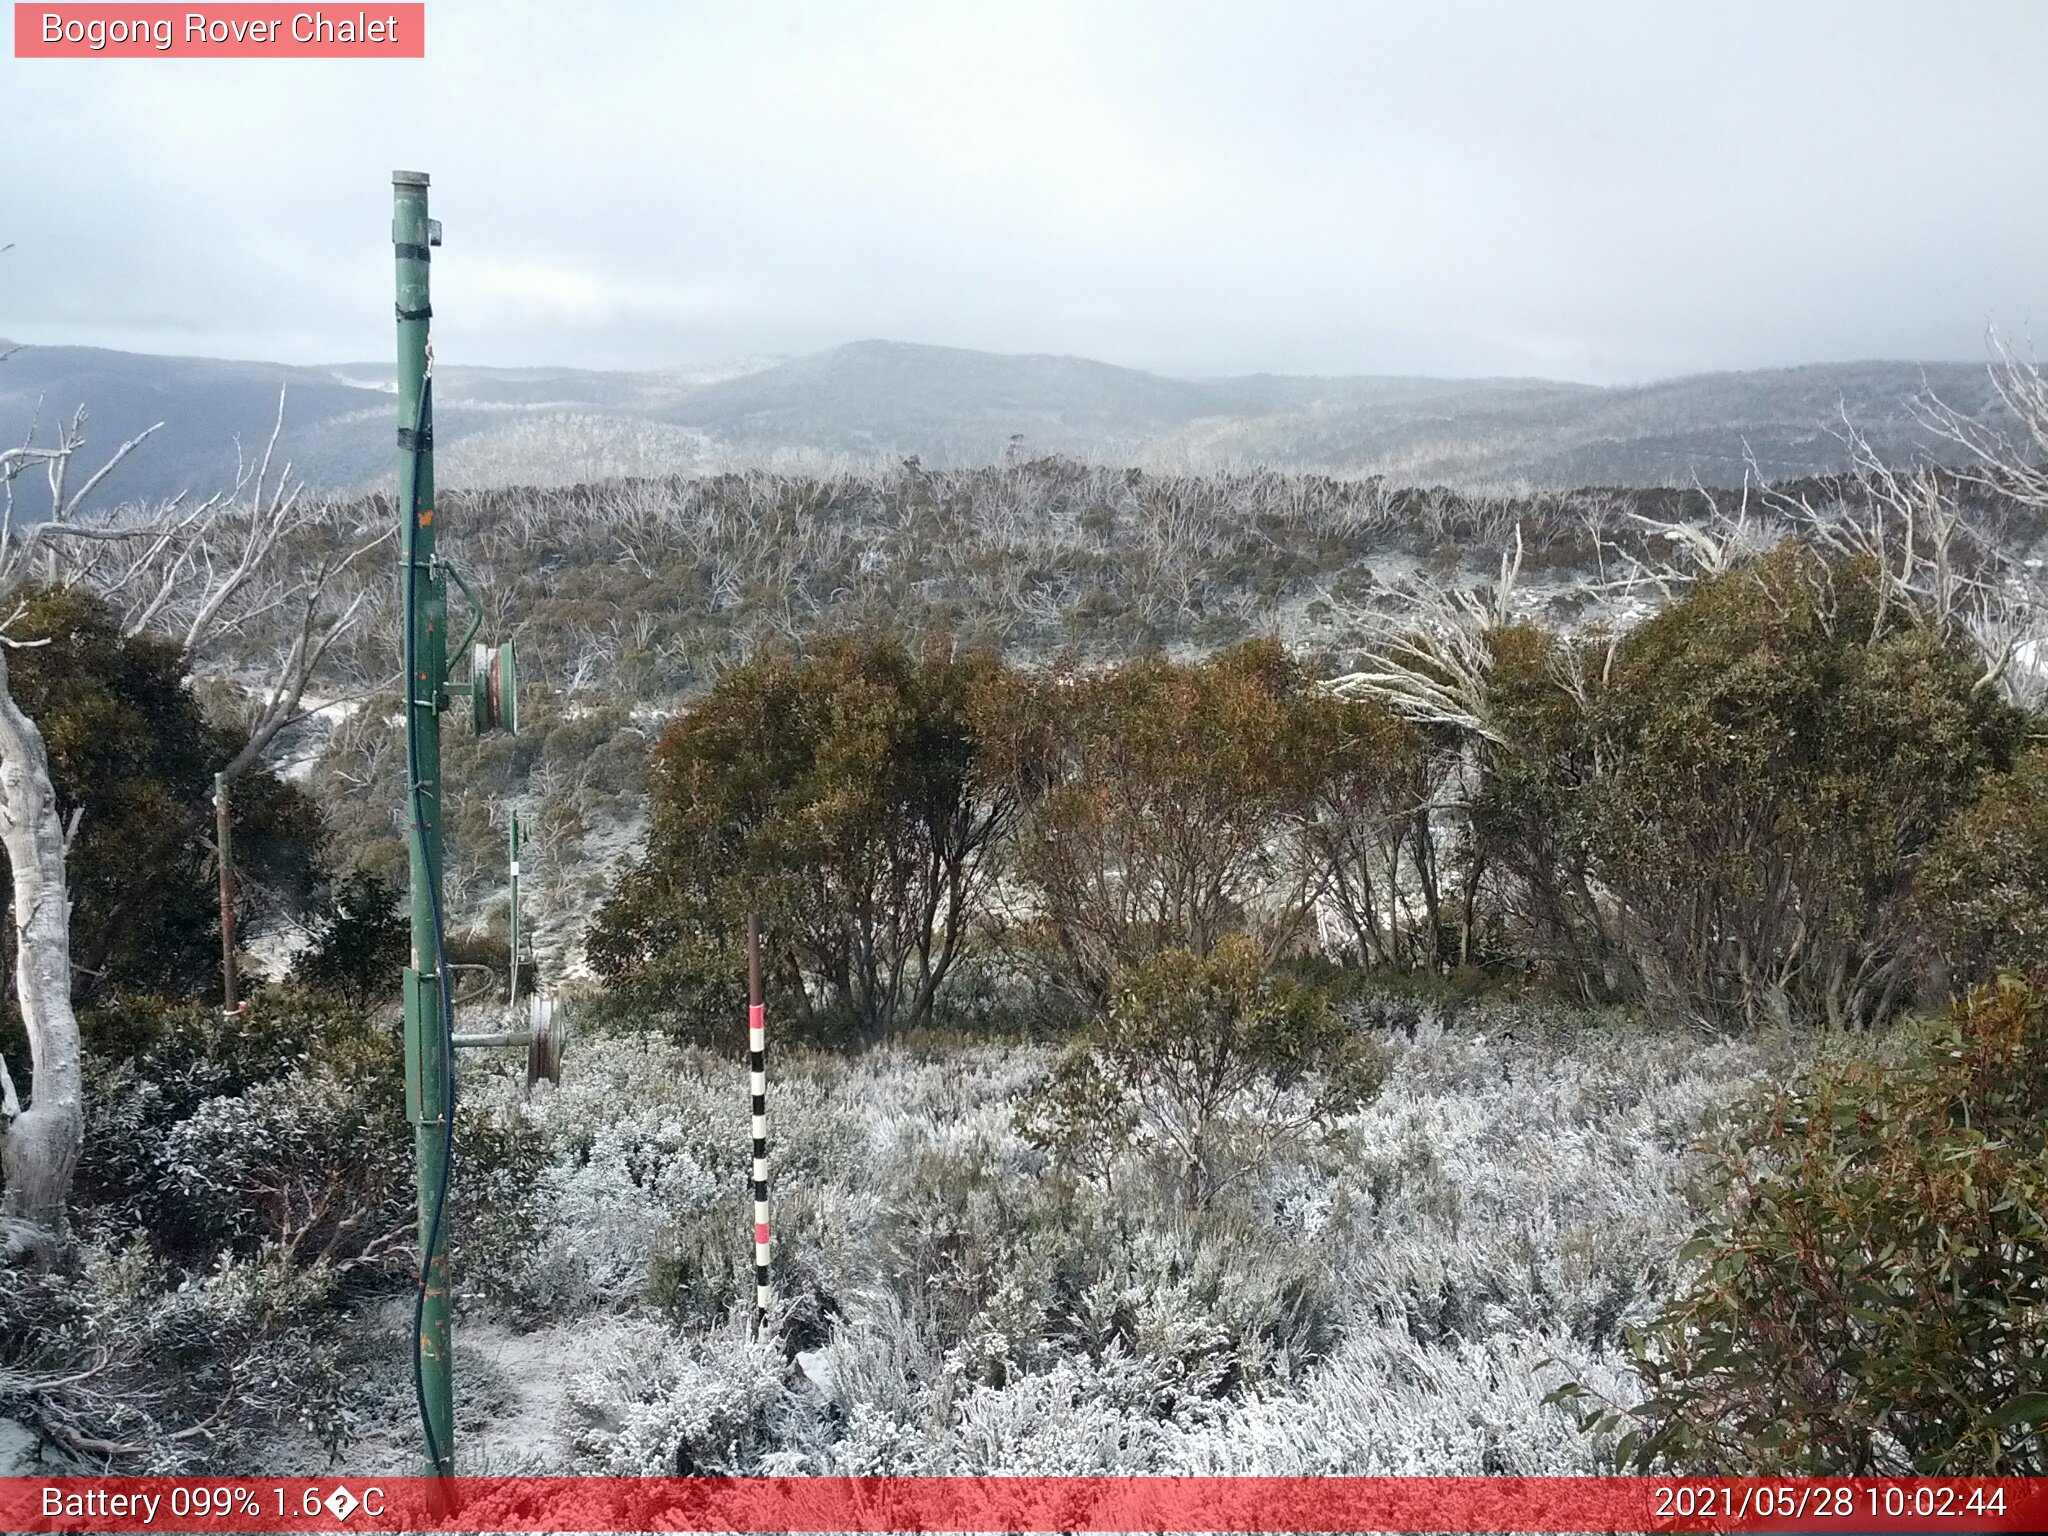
[{"left": 1585, "top": 543, "right": 2025, "bottom": 1028}]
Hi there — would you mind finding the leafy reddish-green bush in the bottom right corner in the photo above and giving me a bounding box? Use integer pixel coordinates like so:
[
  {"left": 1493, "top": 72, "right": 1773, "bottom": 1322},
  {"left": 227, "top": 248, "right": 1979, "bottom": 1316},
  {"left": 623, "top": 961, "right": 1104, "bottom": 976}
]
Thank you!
[{"left": 1567, "top": 979, "right": 2048, "bottom": 1477}]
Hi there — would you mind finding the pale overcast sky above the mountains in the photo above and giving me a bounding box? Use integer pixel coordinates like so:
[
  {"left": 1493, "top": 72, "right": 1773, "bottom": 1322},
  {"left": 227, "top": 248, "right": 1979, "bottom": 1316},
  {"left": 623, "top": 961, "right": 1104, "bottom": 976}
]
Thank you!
[{"left": 0, "top": 0, "right": 2048, "bottom": 383}]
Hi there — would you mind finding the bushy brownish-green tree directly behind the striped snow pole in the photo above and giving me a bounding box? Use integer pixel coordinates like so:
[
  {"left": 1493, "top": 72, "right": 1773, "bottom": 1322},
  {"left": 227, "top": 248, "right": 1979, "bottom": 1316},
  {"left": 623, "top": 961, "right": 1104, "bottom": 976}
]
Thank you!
[{"left": 590, "top": 637, "right": 1016, "bottom": 1042}]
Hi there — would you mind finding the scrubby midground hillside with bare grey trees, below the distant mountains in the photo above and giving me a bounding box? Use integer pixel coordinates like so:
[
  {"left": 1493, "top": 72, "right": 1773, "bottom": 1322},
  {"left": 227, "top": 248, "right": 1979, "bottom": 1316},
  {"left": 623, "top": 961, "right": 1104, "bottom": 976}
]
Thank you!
[{"left": 195, "top": 459, "right": 2036, "bottom": 978}]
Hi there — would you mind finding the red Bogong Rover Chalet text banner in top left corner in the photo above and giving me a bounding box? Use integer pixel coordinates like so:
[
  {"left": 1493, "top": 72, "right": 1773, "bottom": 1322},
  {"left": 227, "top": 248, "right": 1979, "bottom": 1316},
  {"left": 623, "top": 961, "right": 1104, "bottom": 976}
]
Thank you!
[{"left": 14, "top": 4, "right": 426, "bottom": 59}]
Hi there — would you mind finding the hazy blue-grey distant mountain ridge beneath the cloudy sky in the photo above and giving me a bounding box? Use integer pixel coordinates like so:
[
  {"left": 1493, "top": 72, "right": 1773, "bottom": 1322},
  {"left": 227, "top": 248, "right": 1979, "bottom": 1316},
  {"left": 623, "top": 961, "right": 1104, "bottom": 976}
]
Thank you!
[{"left": 0, "top": 342, "right": 1997, "bottom": 498}]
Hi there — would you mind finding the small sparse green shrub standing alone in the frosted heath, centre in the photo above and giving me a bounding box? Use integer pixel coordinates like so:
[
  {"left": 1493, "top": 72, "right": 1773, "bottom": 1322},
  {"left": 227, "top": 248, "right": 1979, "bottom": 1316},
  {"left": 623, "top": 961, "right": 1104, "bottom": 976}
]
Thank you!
[{"left": 1020, "top": 934, "right": 1386, "bottom": 1210}]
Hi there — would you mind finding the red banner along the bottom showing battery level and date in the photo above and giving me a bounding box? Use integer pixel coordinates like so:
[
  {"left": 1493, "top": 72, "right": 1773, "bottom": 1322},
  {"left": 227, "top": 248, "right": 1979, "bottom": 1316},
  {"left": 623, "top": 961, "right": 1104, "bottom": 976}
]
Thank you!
[{"left": 0, "top": 1477, "right": 2048, "bottom": 1532}]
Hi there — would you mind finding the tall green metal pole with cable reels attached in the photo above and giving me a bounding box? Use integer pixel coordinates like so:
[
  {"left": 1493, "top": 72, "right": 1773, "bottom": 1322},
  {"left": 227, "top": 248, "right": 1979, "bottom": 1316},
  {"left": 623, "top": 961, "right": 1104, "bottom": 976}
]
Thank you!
[{"left": 391, "top": 170, "right": 455, "bottom": 1477}]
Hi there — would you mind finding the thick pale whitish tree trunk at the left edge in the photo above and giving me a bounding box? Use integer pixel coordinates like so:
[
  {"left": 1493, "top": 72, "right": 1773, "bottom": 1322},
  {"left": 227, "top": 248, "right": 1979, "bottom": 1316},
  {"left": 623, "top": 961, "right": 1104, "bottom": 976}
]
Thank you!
[{"left": 0, "top": 649, "right": 86, "bottom": 1231}]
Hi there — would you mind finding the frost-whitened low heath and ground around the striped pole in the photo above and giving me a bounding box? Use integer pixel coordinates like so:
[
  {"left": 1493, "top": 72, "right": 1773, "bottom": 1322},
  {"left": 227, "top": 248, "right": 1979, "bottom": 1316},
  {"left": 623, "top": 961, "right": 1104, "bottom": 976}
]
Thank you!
[{"left": 303, "top": 1004, "right": 1794, "bottom": 1475}]
